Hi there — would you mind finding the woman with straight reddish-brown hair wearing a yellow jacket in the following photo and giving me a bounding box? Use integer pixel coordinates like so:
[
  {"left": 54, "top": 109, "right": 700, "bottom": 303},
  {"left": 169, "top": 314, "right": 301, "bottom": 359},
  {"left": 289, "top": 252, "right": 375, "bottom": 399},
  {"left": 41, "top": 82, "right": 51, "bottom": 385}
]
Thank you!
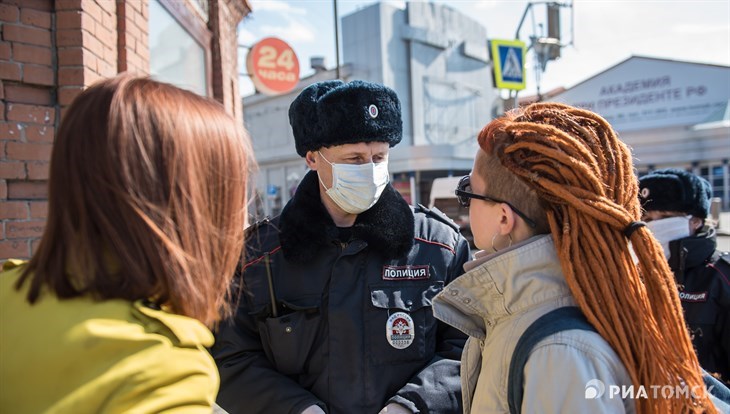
[{"left": 0, "top": 75, "right": 251, "bottom": 413}]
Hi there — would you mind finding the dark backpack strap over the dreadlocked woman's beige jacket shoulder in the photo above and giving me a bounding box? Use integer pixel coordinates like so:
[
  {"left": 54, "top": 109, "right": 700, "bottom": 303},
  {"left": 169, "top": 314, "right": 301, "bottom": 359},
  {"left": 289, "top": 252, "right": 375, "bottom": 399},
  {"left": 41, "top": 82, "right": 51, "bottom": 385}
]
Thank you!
[{"left": 507, "top": 306, "right": 597, "bottom": 414}]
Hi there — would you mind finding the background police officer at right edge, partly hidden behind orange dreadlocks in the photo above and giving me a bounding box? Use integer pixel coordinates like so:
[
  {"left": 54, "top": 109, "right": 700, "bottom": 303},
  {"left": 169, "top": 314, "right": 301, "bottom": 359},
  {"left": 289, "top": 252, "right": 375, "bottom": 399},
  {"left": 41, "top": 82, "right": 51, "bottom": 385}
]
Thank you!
[{"left": 639, "top": 168, "right": 730, "bottom": 382}]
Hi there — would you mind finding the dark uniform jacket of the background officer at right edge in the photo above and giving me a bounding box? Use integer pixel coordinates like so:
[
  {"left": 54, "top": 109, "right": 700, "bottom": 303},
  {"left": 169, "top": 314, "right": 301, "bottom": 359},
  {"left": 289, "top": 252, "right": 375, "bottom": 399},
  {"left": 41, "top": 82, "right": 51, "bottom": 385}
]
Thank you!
[{"left": 669, "top": 229, "right": 730, "bottom": 383}]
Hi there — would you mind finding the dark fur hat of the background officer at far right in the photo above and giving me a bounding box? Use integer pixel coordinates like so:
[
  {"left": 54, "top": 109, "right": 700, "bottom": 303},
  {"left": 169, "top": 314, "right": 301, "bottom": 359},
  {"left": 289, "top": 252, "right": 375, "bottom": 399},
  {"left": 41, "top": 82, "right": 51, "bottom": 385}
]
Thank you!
[{"left": 639, "top": 168, "right": 712, "bottom": 219}]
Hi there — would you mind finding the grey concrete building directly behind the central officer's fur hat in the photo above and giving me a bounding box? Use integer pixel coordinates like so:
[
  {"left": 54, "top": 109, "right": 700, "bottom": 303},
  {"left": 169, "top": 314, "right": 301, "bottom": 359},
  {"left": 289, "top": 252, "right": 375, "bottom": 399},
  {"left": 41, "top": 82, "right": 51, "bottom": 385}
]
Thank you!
[{"left": 243, "top": 2, "right": 497, "bottom": 215}]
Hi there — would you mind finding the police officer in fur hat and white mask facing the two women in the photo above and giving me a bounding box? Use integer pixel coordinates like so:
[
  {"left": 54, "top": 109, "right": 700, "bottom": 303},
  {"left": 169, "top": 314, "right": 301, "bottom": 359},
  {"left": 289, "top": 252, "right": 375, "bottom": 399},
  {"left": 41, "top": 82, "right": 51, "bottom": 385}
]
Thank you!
[{"left": 212, "top": 80, "right": 469, "bottom": 414}]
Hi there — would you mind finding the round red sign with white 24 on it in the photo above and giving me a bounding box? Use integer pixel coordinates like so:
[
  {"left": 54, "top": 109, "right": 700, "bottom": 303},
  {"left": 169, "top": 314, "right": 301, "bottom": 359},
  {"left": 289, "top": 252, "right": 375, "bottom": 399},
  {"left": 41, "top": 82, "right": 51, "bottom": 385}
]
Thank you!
[{"left": 246, "top": 37, "right": 299, "bottom": 95}]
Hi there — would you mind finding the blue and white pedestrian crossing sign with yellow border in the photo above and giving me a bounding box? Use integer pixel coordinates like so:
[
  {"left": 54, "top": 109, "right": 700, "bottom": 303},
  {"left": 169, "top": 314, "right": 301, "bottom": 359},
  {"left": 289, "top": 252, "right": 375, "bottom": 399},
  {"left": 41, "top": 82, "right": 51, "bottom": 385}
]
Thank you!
[{"left": 489, "top": 39, "right": 527, "bottom": 91}]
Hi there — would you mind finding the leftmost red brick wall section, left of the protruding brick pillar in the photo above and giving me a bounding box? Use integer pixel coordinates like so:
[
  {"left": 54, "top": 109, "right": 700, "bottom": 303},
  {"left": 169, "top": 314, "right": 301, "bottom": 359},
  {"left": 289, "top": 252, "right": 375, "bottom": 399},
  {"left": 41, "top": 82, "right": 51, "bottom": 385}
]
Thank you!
[{"left": 0, "top": 0, "right": 58, "bottom": 259}]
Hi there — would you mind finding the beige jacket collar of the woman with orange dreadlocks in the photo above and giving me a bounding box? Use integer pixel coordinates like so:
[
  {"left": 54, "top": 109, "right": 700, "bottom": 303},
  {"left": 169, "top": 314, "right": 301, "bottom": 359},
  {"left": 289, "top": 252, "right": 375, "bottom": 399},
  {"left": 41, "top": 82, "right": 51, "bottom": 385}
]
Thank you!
[{"left": 433, "top": 235, "right": 571, "bottom": 338}]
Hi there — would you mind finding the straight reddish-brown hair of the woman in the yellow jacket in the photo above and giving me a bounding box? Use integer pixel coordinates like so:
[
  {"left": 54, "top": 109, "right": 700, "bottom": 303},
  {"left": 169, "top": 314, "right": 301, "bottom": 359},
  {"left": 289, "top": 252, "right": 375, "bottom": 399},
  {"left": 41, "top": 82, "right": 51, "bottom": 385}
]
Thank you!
[{"left": 17, "top": 75, "right": 252, "bottom": 326}]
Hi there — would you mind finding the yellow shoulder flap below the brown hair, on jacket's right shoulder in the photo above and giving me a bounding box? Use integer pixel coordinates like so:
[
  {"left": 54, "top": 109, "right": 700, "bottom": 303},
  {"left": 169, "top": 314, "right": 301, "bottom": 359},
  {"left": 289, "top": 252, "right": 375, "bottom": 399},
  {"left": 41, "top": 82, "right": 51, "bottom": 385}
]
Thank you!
[{"left": 132, "top": 300, "right": 213, "bottom": 348}]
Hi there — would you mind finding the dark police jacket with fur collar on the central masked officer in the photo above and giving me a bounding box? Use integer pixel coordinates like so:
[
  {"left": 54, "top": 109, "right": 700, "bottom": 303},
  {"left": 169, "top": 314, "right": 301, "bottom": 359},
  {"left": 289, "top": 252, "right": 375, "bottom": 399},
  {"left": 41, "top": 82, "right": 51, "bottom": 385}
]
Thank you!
[{"left": 212, "top": 172, "right": 469, "bottom": 414}]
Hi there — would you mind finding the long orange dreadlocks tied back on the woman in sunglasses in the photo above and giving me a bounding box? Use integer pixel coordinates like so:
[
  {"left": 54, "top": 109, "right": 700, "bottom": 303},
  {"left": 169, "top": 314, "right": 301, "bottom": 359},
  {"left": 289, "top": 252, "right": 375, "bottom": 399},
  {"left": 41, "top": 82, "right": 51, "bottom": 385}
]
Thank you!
[{"left": 479, "top": 103, "right": 716, "bottom": 414}]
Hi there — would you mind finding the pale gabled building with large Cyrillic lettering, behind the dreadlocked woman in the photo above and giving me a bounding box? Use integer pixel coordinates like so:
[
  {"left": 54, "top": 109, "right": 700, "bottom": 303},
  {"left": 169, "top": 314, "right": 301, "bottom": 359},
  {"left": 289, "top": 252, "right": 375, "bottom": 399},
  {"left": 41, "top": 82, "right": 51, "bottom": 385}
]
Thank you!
[{"left": 552, "top": 56, "right": 730, "bottom": 211}]
